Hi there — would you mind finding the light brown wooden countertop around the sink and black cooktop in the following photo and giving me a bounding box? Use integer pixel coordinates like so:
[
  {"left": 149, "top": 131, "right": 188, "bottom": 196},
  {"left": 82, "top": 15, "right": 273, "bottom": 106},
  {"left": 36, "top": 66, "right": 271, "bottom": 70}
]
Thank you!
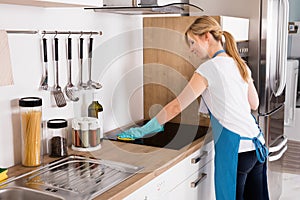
[{"left": 4, "top": 130, "right": 211, "bottom": 200}]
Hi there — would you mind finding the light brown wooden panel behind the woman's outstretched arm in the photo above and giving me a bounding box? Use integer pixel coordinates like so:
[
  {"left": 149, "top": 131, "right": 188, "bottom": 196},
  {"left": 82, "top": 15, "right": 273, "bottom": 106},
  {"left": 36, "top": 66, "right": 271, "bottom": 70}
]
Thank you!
[{"left": 143, "top": 16, "right": 209, "bottom": 126}]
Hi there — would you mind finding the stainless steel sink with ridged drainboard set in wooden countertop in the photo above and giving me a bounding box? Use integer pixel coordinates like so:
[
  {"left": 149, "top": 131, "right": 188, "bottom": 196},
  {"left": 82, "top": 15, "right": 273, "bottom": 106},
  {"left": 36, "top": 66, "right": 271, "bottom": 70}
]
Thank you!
[{"left": 0, "top": 156, "right": 143, "bottom": 200}]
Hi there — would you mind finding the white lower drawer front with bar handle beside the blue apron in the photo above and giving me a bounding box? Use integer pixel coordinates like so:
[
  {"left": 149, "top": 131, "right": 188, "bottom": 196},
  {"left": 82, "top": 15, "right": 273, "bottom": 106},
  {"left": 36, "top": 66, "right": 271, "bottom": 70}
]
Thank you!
[{"left": 160, "top": 160, "right": 216, "bottom": 200}]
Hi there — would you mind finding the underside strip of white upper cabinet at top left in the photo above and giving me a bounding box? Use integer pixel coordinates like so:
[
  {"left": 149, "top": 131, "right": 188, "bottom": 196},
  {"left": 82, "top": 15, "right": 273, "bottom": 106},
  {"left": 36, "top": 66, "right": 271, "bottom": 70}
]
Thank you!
[{"left": 0, "top": 0, "right": 103, "bottom": 7}]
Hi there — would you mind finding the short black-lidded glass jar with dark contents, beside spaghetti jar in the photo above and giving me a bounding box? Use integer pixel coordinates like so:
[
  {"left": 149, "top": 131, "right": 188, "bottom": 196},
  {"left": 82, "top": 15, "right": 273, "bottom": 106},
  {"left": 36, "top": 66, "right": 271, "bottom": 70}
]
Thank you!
[{"left": 47, "top": 119, "right": 68, "bottom": 157}]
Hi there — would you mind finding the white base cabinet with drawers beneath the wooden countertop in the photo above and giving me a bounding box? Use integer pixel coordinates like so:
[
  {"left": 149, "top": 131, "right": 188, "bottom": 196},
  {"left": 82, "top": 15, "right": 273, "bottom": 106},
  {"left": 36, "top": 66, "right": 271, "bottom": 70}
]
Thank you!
[{"left": 124, "top": 141, "right": 214, "bottom": 200}]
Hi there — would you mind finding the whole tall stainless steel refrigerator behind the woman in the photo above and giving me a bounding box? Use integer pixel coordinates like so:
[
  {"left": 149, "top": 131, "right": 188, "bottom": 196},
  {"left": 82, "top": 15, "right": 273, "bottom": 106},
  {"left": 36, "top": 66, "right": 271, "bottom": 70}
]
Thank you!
[{"left": 249, "top": 0, "right": 289, "bottom": 200}]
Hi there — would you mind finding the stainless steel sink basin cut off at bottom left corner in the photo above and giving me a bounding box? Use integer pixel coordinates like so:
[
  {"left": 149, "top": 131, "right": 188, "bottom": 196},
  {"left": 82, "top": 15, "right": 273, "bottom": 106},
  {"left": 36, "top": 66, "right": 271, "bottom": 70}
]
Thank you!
[{"left": 0, "top": 187, "right": 63, "bottom": 200}]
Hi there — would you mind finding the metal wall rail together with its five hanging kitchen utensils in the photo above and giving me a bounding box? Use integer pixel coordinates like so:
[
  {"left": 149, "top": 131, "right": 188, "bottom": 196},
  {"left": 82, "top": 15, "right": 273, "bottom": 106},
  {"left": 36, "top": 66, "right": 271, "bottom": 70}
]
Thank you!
[{"left": 6, "top": 30, "right": 102, "bottom": 107}]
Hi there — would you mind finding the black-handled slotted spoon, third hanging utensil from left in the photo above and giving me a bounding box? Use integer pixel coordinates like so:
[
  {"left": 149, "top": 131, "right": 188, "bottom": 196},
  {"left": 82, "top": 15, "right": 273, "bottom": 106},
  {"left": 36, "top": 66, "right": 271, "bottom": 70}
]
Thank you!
[{"left": 65, "top": 37, "right": 79, "bottom": 101}]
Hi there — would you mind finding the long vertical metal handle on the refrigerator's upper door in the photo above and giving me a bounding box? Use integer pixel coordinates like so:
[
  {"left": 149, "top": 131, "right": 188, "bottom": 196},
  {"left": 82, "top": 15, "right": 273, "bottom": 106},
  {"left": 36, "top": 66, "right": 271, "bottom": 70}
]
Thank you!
[{"left": 274, "top": 0, "right": 289, "bottom": 97}]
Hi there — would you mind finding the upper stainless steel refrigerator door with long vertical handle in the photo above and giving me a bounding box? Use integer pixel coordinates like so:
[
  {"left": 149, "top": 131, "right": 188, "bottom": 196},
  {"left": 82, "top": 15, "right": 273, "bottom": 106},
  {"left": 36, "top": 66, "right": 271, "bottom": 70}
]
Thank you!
[{"left": 258, "top": 0, "right": 289, "bottom": 114}]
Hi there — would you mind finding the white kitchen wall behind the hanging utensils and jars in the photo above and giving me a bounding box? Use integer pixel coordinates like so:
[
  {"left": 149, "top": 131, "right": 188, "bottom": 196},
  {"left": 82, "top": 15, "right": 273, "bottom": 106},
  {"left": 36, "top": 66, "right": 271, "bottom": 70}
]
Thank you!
[{"left": 0, "top": 5, "right": 143, "bottom": 167}]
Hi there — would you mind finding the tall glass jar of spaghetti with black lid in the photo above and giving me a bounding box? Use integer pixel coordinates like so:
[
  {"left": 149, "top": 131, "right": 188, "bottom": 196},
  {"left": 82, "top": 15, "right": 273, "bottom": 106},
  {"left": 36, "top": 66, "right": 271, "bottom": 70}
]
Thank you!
[{"left": 19, "top": 97, "right": 42, "bottom": 167}]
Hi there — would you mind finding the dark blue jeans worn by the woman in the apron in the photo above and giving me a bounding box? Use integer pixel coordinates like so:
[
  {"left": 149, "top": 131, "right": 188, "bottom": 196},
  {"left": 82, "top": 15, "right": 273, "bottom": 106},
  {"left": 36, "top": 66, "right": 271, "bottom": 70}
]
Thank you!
[{"left": 236, "top": 151, "right": 268, "bottom": 200}]
